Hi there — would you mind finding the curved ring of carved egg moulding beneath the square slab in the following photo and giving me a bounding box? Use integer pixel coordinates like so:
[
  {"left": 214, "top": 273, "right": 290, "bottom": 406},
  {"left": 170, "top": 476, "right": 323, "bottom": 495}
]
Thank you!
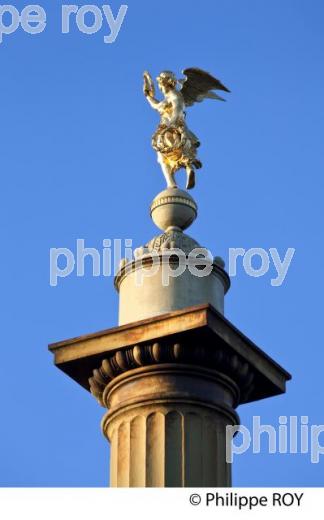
[{"left": 89, "top": 340, "right": 254, "bottom": 408}]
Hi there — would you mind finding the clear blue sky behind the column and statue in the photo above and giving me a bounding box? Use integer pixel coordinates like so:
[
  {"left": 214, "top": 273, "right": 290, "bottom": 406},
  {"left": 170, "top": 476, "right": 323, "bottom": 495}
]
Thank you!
[{"left": 0, "top": 0, "right": 324, "bottom": 486}]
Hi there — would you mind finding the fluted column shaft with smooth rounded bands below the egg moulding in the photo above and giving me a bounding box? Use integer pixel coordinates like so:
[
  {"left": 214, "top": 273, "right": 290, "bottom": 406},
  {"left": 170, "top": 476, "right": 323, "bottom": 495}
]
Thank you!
[{"left": 102, "top": 363, "right": 238, "bottom": 487}]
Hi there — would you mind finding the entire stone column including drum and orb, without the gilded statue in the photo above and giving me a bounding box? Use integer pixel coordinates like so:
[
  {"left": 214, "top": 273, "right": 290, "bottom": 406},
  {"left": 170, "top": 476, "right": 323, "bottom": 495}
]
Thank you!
[{"left": 50, "top": 188, "right": 290, "bottom": 487}]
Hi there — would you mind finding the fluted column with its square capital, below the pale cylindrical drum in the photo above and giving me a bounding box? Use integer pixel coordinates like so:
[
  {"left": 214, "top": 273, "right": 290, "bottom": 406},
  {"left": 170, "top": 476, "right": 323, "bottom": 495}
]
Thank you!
[{"left": 50, "top": 305, "right": 290, "bottom": 487}]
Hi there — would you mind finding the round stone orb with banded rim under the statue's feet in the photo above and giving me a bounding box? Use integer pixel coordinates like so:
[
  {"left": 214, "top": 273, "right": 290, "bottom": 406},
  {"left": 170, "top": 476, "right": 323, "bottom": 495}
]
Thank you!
[{"left": 151, "top": 188, "right": 198, "bottom": 231}]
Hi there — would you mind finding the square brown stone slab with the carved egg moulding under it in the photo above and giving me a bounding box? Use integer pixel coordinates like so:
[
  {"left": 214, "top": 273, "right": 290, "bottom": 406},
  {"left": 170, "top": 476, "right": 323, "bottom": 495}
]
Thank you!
[{"left": 49, "top": 305, "right": 291, "bottom": 403}]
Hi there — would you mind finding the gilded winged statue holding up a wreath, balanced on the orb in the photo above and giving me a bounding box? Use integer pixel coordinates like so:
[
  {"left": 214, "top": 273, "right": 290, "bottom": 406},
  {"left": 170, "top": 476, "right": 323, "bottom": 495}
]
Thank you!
[{"left": 143, "top": 68, "right": 230, "bottom": 190}]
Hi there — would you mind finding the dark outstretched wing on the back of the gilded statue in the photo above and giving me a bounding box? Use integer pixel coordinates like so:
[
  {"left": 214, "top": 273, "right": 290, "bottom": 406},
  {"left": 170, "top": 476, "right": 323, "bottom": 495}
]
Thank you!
[{"left": 180, "top": 68, "right": 230, "bottom": 107}]
